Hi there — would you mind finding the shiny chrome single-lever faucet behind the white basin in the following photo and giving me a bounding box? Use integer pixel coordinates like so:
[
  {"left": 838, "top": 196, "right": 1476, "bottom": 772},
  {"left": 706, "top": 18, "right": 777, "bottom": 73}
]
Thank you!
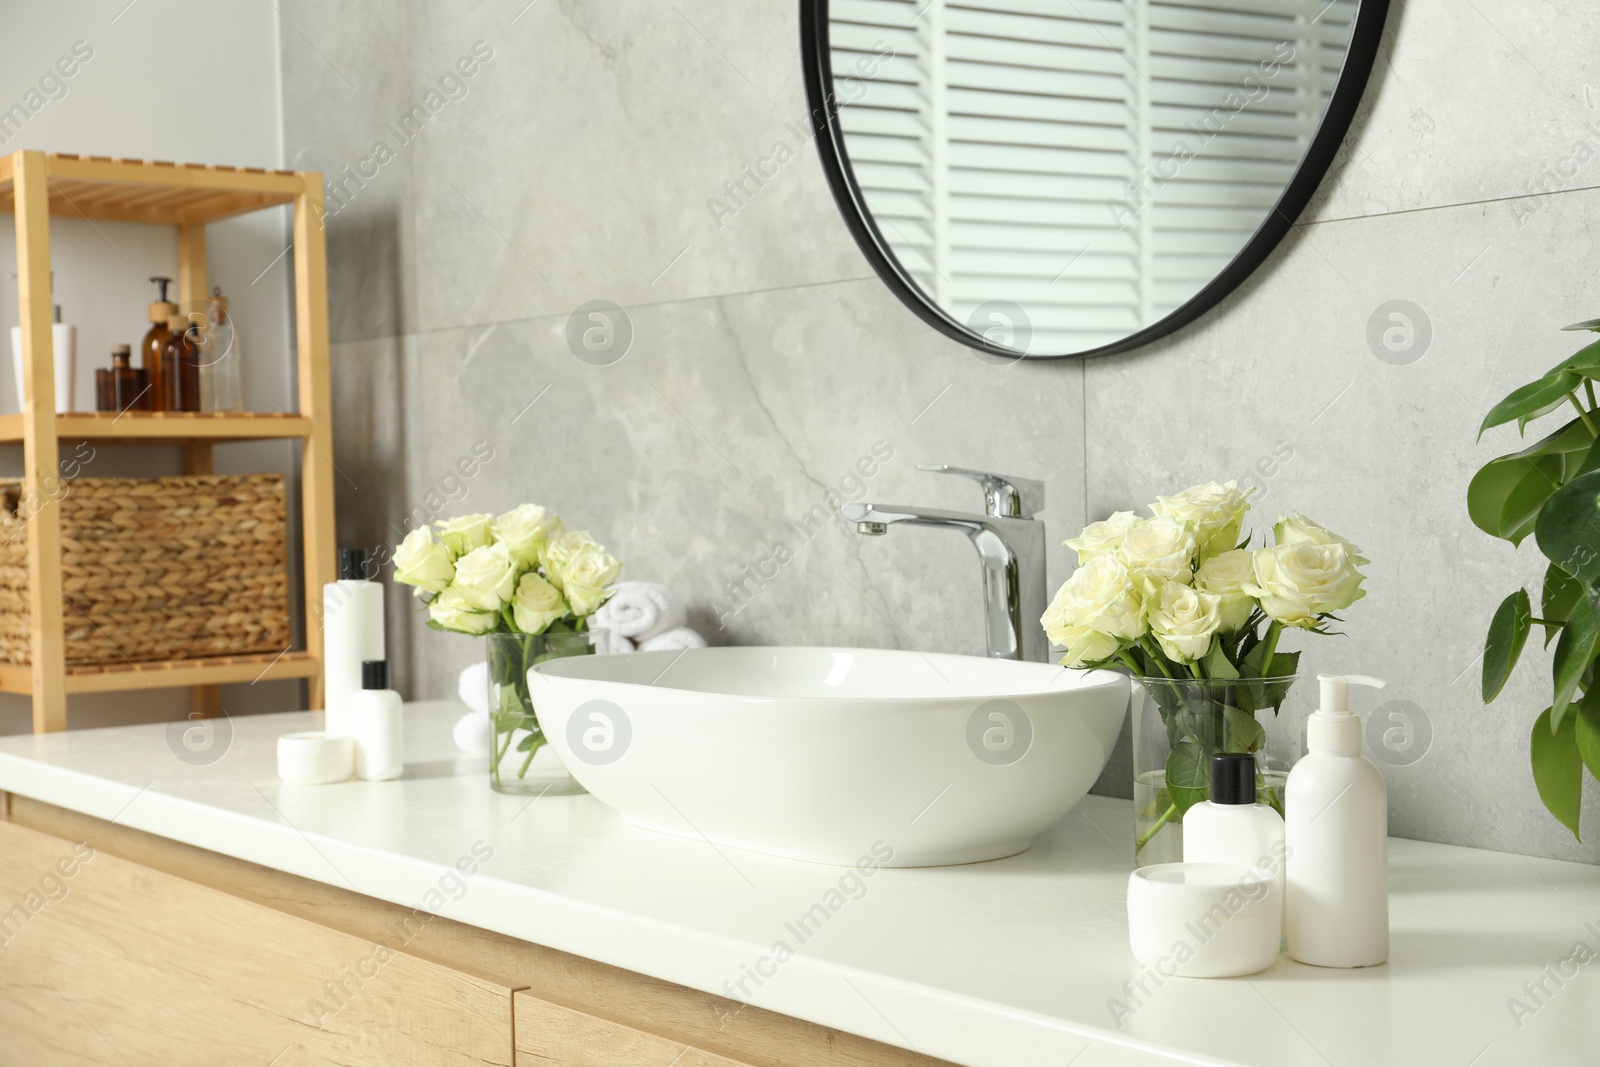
[{"left": 840, "top": 464, "right": 1050, "bottom": 662}]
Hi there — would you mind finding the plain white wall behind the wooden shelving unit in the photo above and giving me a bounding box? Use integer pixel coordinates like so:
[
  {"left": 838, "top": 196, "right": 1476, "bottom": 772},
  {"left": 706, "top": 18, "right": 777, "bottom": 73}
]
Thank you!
[{"left": 0, "top": 0, "right": 298, "bottom": 734}]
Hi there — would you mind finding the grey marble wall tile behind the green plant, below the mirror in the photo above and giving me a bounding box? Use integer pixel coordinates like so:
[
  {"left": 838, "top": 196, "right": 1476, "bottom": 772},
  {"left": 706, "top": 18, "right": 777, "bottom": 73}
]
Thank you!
[{"left": 1086, "top": 183, "right": 1600, "bottom": 861}]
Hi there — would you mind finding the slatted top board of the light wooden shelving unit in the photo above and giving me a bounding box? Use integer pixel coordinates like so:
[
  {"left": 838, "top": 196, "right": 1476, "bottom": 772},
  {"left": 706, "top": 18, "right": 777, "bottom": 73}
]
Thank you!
[{"left": 0, "top": 154, "right": 301, "bottom": 226}]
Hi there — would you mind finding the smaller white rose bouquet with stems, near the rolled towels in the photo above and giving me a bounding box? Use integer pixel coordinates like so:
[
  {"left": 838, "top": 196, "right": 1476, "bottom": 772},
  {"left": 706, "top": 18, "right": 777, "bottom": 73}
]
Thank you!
[{"left": 395, "top": 504, "right": 622, "bottom": 792}]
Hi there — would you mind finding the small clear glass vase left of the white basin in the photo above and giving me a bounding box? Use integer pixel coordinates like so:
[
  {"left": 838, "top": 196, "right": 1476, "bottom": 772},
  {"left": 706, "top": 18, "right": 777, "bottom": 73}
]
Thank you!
[{"left": 488, "top": 630, "right": 603, "bottom": 797}]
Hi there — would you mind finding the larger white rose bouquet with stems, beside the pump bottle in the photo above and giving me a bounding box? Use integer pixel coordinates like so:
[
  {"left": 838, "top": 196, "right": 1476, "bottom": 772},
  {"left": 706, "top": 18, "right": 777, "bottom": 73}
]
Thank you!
[{"left": 1040, "top": 482, "right": 1368, "bottom": 848}]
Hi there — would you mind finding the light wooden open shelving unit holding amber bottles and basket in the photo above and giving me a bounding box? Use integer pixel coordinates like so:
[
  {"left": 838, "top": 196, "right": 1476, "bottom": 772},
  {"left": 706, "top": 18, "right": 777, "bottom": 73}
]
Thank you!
[{"left": 0, "top": 150, "right": 336, "bottom": 733}]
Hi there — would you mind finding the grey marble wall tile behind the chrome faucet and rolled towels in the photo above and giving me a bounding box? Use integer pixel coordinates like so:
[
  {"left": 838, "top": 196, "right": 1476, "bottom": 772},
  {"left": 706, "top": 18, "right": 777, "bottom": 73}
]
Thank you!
[{"left": 353, "top": 282, "right": 1083, "bottom": 697}]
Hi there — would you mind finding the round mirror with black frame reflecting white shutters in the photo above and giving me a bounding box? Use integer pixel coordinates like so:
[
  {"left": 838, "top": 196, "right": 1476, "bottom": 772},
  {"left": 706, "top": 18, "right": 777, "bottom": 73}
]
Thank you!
[{"left": 800, "top": 0, "right": 1387, "bottom": 360}]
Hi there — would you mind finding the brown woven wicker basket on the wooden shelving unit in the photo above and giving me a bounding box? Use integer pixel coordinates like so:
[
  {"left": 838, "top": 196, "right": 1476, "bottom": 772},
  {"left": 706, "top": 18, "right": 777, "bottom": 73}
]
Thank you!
[{"left": 0, "top": 474, "right": 290, "bottom": 665}]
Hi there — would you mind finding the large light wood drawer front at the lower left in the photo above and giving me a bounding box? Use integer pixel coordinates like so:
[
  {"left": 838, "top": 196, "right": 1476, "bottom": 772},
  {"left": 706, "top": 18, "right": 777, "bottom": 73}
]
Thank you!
[{"left": 0, "top": 821, "right": 515, "bottom": 1067}]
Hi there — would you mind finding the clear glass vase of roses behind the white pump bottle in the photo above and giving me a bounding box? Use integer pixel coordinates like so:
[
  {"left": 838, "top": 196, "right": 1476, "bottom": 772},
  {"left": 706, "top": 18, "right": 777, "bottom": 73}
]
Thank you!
[{"left": 1131, "top": 675, "right": 1296, "bottom": 867}]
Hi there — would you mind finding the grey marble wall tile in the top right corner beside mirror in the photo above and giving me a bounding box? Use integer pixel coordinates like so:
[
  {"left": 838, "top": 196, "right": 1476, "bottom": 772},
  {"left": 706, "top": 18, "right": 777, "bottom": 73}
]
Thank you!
[{"left": 1306, "top": 0, "right": 1600, "bottom": 219}]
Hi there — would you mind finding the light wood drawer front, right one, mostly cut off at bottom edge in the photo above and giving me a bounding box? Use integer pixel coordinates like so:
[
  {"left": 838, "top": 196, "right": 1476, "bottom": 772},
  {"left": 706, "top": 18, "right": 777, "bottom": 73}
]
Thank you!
[{"left": 512, "top": 992, "right": 754, "bottom": 1067}]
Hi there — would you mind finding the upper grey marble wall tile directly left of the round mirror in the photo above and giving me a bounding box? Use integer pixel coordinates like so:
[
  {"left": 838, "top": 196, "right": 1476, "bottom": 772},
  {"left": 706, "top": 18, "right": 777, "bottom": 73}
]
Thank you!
[{"left": 406, "top": 0, "right": 870, "bottom": 330}]
